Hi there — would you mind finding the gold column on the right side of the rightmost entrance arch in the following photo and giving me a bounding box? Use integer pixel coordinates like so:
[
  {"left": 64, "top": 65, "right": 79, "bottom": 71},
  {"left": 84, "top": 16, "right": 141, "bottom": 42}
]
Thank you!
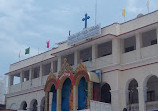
[{"left": 87, "top": 82, "right": 93, "bottom": 109}]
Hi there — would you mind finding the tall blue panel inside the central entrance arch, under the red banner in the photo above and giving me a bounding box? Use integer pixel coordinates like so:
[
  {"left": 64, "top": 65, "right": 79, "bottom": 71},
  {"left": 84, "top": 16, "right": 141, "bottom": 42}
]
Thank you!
[{"left": 61, "top": 79, "right": 71, "bottom": 111}]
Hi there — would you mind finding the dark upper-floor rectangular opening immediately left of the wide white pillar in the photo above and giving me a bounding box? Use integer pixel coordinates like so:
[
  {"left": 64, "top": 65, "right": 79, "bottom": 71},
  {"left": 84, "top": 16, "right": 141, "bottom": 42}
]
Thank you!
[{"left": 98, "top": 41, "right": 112, "bottom": 58}]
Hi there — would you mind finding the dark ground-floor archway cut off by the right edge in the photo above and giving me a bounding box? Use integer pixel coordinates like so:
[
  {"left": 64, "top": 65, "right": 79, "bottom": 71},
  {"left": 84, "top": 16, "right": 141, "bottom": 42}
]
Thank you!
[{"left": 147, "top": 76, "right": 158, "bottom": 102}]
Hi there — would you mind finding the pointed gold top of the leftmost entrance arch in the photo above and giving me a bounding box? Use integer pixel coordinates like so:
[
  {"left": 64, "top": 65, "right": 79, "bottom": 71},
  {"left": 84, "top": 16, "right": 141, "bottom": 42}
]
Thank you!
[{"left": 44, "top": 73, "right": 57, "bottom": 92}]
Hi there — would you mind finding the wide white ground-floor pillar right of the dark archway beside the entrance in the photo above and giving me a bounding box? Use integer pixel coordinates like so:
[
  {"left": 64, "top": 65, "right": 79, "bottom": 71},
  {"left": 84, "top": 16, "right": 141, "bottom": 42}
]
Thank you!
[{"left": 111, "top": 90, "right": 123, "bottom": 111}]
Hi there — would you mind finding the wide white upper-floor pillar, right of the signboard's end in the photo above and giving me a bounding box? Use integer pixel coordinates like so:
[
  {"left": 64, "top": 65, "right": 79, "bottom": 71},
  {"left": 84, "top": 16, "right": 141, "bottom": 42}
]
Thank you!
[{"left": 112, "top": 37, "right": 121, "bottom": 64}]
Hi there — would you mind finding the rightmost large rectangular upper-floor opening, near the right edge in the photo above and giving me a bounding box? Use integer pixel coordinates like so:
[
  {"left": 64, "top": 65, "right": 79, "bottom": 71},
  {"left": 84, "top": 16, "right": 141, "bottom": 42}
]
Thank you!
[{"left": 142, "top": 29, "right": 157, "bottom": 47}]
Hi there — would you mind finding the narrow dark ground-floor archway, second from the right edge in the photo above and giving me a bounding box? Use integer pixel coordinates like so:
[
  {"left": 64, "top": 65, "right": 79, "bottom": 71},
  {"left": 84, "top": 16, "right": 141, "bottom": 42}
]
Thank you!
[{"left": 128, "top": 79, "right": 138, "bottom": 105}]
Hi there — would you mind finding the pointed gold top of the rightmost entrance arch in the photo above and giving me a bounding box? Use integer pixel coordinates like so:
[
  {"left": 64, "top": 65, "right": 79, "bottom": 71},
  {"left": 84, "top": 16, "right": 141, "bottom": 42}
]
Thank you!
[{"left": 74, "top": 63, "right": 90, "bottom": 86}]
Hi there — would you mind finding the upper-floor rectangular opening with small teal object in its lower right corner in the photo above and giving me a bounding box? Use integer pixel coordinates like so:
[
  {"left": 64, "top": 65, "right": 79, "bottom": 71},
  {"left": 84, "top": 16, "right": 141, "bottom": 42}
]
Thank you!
[{"left": 80, "top": 47, "right": 92, "bottom": 62}]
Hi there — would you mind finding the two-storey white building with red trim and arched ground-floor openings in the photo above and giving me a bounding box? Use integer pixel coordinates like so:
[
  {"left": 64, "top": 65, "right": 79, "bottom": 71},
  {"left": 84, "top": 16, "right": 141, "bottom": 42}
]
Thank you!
[{"left": 6, "top": 11, "right": 158, "bottom": 111}]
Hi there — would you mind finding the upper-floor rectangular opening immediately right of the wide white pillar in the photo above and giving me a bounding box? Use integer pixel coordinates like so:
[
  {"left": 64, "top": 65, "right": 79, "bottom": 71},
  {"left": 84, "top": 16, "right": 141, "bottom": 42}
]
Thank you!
[{"left": 124, "top": 36, "right": 136, "bottom": 53}]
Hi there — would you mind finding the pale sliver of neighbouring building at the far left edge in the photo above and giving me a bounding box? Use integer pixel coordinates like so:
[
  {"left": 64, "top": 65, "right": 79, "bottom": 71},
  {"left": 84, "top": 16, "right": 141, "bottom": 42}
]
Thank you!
[{"left": 0, "top": 76, "right": 6, "bottom": 104}]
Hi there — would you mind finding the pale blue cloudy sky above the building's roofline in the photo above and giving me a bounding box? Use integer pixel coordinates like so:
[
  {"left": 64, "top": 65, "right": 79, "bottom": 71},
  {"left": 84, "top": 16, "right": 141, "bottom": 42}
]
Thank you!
[{"left": 0, "top": 0, "right": 158, "bottom": 77}]
